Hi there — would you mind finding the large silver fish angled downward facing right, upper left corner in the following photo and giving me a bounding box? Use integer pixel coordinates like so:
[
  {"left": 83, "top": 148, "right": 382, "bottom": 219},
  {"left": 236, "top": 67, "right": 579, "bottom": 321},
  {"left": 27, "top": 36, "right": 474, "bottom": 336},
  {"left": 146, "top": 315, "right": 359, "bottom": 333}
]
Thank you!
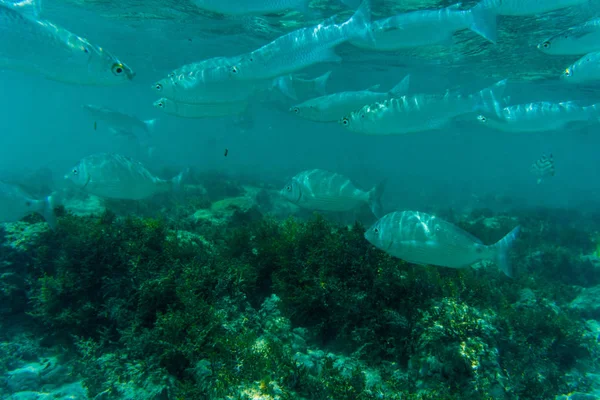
[{"left": 0, "top": 4, "right": 134, "bottom": 85}]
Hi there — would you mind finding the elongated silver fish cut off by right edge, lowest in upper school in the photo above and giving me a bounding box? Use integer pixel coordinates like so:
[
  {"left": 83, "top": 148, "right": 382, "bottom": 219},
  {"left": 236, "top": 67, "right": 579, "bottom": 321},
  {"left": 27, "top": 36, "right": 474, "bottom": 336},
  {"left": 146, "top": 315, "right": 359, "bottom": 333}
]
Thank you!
[{"left": 477, "top": 101, "right": 600, "bottom": 132}]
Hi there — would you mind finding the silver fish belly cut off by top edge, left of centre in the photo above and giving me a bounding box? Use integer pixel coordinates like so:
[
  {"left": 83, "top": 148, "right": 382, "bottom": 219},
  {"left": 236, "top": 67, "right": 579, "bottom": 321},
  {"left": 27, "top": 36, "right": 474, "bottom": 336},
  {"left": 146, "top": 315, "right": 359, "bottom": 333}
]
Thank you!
[{"left": 192, "top": 0, "right": 309, "bottom": 15}]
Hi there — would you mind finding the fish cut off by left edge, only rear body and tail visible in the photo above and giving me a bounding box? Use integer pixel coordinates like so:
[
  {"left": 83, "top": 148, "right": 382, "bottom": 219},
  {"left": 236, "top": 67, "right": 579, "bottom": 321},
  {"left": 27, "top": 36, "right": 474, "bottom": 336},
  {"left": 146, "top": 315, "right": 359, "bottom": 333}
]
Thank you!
[{"left": 0, "top": 181, "right": 57, "bottom": 229}]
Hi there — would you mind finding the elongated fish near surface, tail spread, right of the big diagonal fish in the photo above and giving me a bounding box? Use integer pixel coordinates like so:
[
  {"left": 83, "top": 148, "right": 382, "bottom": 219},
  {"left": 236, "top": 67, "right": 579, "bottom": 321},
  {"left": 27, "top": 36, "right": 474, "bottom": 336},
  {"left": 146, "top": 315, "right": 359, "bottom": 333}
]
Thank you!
[{"left": 350, "top": 4, "right": 497, "bottom": 51}]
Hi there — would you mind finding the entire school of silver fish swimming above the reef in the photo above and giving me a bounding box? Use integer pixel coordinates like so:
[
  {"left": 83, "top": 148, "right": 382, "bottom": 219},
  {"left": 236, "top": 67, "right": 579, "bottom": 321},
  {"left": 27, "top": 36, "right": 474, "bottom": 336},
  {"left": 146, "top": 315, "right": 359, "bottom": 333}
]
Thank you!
[{"left": 5, "top": 0, "right": 600, "bottom": 276}]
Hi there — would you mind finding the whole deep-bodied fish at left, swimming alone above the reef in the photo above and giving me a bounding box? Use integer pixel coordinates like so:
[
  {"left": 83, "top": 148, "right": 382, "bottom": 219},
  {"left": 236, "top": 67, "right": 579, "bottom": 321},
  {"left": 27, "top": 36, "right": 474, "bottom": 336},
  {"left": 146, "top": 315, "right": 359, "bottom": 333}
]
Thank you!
[{"left": 65, "top": 153, "right": 188, "bottom": 200}]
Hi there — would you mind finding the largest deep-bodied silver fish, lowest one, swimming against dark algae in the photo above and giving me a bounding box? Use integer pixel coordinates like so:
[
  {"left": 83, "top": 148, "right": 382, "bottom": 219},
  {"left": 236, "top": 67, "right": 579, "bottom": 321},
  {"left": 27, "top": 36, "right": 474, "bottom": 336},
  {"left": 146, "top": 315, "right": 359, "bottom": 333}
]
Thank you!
[{"left": 365, "top": 211, "right": 520, "bottom": 277}]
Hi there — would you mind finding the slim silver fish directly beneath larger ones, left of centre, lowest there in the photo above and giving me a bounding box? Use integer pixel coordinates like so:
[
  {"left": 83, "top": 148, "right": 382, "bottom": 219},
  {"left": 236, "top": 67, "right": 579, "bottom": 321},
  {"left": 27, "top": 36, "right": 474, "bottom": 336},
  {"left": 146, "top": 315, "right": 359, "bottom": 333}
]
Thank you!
[{"left": 154, "top": 97, "right": 248, "bottom": 118}]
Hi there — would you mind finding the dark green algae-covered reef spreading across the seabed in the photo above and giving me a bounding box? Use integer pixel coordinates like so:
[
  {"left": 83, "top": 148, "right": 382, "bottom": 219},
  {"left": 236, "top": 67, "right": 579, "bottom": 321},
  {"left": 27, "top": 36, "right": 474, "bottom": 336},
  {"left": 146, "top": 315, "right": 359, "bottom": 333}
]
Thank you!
[{"left": 0, "top": 205, "right": 600, "bottom": 400}]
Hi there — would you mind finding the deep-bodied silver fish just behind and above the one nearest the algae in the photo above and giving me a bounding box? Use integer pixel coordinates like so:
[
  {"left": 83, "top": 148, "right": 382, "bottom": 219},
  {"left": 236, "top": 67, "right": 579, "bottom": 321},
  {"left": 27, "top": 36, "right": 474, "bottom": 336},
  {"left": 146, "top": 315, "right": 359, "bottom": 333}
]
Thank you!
[{"left": 280, "top": 169, "right": 384, "bottom": 218}]
